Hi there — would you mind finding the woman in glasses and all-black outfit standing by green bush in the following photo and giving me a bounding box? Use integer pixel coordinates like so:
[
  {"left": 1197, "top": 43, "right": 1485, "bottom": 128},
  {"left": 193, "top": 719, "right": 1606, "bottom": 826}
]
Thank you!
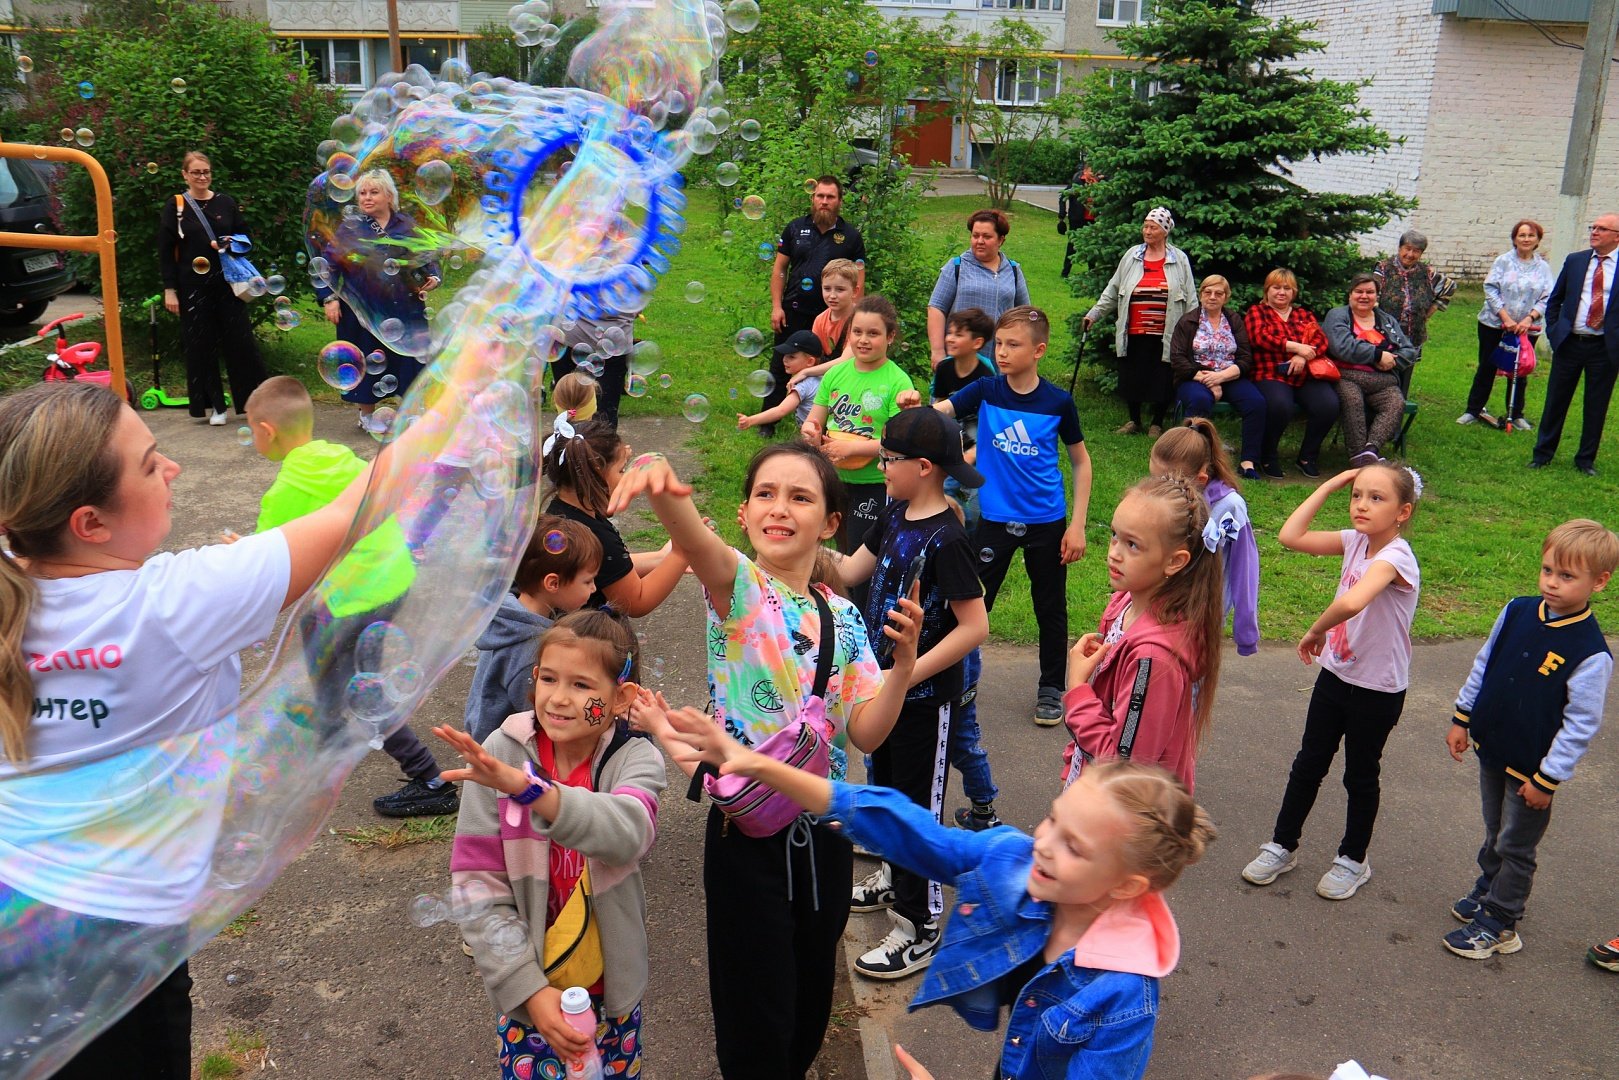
[{"left": 157, "top": 151, "right": 267, "bottom": 427}]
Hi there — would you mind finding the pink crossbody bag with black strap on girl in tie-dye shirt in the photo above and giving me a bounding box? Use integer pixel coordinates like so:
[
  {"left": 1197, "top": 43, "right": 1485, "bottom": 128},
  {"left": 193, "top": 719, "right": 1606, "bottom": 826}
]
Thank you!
[{"left": 686, "top": 586, "right": 834, "bottom": 837}]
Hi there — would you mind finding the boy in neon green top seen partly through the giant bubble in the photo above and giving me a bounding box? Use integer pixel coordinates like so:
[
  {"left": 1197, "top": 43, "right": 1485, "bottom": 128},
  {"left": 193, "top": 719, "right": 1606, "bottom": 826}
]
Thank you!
[{"left": 227, "top": 376, "right": 460, "bottom": 818}]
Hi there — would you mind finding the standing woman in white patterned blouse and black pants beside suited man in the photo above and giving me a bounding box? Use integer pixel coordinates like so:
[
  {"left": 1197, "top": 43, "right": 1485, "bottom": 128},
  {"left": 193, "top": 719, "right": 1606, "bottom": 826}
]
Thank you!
[{"left": 1455, "top": 219, "right": 1557, "bottom": 431}]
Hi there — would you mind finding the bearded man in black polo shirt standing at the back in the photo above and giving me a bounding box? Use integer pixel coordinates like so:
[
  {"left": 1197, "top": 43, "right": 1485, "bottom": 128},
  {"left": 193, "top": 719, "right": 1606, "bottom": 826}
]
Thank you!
[{"left": 764, "top": 176, "right": 866, "bottom": 408}]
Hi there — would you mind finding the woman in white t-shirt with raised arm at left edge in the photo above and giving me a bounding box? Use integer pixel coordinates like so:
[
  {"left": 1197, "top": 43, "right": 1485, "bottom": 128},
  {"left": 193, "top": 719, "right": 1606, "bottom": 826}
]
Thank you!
[{"left": 0, "top": 382, "right": 366, "bottom": 1080}]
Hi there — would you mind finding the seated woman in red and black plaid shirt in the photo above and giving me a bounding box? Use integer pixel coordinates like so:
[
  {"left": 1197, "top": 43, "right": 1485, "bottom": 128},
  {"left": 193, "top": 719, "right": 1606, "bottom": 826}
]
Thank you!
[{"left": 1243, "top": 270, "right": 1339, "bottom": 478}]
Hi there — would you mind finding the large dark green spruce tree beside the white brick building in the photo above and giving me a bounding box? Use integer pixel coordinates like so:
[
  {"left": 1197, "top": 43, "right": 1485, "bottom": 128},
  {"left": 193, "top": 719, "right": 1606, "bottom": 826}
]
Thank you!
[{"left": 1073, "top": 0, "right": 1415, "bottom": 353}]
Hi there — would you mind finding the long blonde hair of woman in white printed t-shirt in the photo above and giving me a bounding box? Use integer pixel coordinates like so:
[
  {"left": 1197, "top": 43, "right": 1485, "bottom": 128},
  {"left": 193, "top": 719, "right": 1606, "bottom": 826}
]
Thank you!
[{"left": 0, "top": 382, "right": 125, "bottom": 764}]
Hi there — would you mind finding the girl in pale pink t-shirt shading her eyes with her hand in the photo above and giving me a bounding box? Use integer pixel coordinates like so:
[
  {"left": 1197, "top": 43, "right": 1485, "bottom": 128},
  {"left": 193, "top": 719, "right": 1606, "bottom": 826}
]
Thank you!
[{"left": 1242, "top": 463, "right": 1421, "bottom": 900}]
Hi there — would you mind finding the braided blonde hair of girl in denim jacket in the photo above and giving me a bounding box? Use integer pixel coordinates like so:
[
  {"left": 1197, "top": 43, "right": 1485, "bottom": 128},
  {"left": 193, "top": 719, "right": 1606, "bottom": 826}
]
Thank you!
[{"left": 1083, "top": 758, "right": 1216, "bottom": 892}]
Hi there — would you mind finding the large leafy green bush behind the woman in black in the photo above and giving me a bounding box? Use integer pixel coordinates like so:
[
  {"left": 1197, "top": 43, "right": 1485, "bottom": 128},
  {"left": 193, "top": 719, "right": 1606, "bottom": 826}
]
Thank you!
[{"left": 16, "top": 0, "right": 340, "bottom": 323}]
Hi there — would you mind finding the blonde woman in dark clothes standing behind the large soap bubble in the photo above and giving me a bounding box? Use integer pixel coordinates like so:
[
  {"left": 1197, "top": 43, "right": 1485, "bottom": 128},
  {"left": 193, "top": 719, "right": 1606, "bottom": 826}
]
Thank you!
[{"left": 314, "top": 168, "right": 439, "bottom": 434}]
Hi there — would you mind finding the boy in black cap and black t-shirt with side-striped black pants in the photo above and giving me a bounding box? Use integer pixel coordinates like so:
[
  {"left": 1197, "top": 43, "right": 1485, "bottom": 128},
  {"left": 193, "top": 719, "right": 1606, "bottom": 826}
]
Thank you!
[{"left": 839, "top": 408, "right": 989, "bottom": 980}]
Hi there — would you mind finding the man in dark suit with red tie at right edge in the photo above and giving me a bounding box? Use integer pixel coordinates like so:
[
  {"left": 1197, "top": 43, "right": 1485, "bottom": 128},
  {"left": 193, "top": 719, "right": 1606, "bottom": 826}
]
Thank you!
[{"left": 1528, "top": 214, "right": 1619, "bottom": 476}]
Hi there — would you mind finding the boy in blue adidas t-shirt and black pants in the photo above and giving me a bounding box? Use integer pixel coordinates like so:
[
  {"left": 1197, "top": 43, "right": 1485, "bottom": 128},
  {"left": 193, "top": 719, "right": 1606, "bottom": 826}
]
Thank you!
[{"left": 934, "top": 306, "right": 1091, "bottom": 727}]
